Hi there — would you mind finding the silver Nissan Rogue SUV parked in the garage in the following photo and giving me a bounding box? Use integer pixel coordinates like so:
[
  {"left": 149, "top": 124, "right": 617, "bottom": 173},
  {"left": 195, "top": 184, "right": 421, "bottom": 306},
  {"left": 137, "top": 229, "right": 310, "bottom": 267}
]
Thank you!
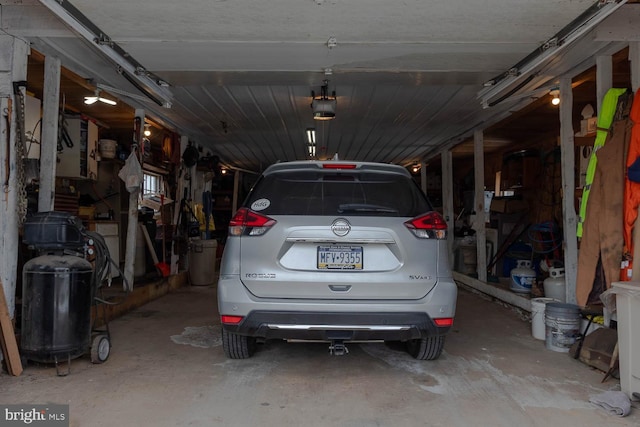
[{"left": 218, "top": 161, "right": 457, "bottom": 360}]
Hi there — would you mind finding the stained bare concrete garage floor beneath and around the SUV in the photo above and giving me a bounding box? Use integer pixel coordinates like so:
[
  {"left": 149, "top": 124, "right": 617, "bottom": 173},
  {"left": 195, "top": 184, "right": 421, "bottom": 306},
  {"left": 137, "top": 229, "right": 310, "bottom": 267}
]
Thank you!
[{"left": 0, "top": 287, "right": 640, "bottom": 427}]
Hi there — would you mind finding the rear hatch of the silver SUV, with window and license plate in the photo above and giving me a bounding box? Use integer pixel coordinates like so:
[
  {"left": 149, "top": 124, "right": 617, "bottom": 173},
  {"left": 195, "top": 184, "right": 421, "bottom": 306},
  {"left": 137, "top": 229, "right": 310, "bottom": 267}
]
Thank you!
[{"left": 230, "top": 162, "right": 446, "bottom": 301}]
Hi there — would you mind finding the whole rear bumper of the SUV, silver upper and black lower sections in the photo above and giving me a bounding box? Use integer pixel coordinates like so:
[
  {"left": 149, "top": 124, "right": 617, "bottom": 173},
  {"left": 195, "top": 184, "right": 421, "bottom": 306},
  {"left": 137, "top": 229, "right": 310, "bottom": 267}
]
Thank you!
[{"left": 218, "top": 275, "right": 458, "bottom": 341}]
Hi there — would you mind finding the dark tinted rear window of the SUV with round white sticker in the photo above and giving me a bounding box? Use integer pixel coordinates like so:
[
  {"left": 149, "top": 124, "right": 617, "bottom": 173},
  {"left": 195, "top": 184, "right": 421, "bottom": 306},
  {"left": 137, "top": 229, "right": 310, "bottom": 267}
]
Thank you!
[{"left": 244, "top": 170, "right": 432, "bottom": 217}]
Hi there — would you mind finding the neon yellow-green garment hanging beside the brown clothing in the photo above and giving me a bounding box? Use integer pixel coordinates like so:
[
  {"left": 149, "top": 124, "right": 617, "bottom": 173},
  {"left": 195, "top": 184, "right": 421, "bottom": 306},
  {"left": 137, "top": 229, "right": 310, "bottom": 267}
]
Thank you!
[{"left": 576, "top": 89, "right": 627, "bottom": 237}]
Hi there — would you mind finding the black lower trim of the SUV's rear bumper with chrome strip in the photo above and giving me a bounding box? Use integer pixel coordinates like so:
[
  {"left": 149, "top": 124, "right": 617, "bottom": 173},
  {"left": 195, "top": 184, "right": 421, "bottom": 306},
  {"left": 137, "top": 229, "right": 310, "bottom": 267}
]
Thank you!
[{"left": 222, "top": 311, "right": 450, "bottom": 341}]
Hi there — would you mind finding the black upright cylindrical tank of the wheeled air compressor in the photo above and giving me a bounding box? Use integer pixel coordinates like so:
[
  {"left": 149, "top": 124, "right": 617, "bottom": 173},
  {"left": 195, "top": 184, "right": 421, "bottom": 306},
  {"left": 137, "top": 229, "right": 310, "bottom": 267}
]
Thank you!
[{"left": 20, "top": 255, "right": 93, "bottom": 363}]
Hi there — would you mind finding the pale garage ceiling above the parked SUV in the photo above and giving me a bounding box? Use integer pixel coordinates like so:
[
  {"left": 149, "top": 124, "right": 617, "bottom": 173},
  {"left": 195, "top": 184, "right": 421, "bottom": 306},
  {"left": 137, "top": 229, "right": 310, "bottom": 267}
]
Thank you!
[{"left": 0, "top": 0, "right": 640, "bottom": 171}]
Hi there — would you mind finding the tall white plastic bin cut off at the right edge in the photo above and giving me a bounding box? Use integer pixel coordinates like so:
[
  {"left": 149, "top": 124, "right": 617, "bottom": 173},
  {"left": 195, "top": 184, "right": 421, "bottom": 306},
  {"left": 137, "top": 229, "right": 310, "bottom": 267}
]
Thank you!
[{"left": 611, "top": 282, "right": 640, "bottom": 398}]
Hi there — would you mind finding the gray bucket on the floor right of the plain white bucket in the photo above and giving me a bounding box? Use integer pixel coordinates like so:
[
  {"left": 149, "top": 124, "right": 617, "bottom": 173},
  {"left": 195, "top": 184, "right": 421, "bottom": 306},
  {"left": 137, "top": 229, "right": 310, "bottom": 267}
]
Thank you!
[{"left": 544, "top": 302, "right": 580, "bottom": 353}]
